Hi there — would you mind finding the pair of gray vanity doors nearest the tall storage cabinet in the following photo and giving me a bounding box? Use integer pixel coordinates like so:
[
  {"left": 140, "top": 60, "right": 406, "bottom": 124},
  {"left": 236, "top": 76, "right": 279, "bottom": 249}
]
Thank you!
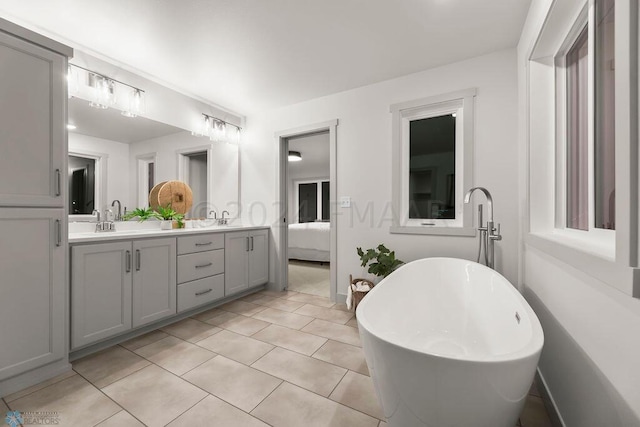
[{"left": 71, "top": 238, "right": 176, "bottom": 349}]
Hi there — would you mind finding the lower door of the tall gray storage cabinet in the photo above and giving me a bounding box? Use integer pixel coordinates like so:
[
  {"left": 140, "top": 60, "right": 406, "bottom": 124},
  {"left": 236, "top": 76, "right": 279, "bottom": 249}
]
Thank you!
[{"left": 0, "top": 209, "right": 67, "bottom": 380}]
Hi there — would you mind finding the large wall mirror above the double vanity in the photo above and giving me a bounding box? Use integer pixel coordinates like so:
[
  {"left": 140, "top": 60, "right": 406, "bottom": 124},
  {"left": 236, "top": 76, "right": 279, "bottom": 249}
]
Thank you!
[{"left": 68, "top": 98, "right": 239, "bottom": 221}]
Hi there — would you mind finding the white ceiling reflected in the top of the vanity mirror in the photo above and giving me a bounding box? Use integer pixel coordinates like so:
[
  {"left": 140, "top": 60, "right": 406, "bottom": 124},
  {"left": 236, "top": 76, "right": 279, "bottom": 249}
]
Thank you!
[{"left": 68, "top": 98, "right": 184, "bottom": 144}]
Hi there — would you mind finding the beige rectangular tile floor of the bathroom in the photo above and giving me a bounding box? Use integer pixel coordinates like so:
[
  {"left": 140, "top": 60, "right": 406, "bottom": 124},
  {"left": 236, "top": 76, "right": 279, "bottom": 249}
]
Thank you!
[{"left": 0, "top": 291, "right": 551, "bottom": 427}]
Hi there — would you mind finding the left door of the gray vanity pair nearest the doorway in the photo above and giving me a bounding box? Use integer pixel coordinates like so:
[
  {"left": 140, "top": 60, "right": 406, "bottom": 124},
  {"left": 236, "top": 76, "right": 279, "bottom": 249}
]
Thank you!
[{"left": 224, "top": 231, "right": 249, "bottom": 296}]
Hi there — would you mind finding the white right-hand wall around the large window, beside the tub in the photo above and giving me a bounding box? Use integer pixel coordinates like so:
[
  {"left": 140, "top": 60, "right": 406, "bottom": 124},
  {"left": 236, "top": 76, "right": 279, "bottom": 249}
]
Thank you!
[{"left": 518, "top": 0, "right": 640, "bottom": 427}]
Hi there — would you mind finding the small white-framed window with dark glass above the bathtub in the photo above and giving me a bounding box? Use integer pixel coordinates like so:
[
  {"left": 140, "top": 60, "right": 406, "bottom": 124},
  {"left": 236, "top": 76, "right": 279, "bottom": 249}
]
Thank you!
[{"left": 391, "top": 89, "right": 475, "bottom": 235}]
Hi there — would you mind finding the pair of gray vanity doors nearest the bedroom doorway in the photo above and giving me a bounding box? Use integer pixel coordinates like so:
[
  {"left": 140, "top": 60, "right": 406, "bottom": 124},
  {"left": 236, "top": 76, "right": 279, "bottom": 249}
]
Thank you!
[{"left": 224, "top": 230, "right": 269, "bottom": 296}]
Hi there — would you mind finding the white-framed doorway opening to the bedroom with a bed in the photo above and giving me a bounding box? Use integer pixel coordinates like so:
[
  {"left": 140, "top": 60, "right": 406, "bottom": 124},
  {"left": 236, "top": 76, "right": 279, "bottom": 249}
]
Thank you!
[{"left": 274, "top": 120, "right": 338, "bottom": 301}]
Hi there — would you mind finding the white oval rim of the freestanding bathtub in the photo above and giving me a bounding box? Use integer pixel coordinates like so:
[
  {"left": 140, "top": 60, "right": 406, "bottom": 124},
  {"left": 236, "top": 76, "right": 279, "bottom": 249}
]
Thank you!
[{"left": 356, "top": 257, "right": 544, "bottom": 363}]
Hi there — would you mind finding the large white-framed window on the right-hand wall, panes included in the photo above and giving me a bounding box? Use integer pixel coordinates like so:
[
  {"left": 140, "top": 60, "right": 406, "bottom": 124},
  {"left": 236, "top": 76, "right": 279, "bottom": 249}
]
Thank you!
[{"left": 523, "top": 0, "right": 640, "bottom": 298}]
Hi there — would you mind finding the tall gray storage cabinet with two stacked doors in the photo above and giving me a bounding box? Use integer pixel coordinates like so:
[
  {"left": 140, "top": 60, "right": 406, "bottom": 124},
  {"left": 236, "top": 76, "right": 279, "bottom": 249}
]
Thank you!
[{"left": 0, "top": 19, "right": 73, "bottom": 397}]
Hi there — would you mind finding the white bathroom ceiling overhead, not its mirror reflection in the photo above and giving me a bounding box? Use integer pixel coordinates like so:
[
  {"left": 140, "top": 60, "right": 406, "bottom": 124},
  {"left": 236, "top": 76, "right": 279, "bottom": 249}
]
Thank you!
[{"left": 0, "top": 0, "right": 530, "bottom": 114}]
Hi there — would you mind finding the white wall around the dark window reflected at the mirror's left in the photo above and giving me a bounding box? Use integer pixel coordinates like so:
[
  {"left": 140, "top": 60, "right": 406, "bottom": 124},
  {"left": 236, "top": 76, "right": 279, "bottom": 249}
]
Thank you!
[{"left": 69, "top": 132, "right": 130, "bottom": 211}]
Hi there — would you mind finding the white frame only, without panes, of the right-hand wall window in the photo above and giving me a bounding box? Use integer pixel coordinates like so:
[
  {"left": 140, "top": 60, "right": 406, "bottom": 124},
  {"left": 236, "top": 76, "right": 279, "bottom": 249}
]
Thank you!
[{"left": 523, "top": 0, "right": 640, "bottom": 298}]
